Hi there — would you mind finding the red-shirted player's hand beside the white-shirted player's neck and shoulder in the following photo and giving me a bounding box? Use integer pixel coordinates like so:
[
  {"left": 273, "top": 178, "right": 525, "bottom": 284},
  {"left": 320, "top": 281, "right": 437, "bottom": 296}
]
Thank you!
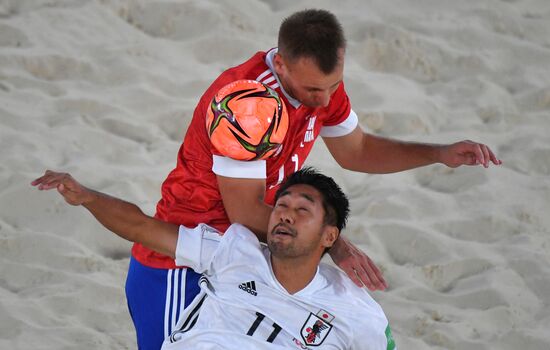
[{"left": 329, "top": 236, "right": 388, "bottom": 291}]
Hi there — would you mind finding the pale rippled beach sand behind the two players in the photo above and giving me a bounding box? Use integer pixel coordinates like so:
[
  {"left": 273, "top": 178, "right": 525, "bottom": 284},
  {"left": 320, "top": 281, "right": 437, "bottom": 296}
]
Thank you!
[{"left": 0, "top": 0, "right": 550, "bottom": 350}]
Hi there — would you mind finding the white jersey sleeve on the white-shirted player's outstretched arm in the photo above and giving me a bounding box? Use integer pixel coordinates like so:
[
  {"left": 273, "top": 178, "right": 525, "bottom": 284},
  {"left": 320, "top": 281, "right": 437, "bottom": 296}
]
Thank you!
[{"left": 176, "top": 224, "right": 222, "bottom": 273}]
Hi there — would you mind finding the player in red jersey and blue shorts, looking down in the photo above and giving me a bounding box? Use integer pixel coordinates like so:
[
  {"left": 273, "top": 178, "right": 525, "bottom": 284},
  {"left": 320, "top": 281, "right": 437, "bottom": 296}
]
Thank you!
[{"left": 126, "top": 10, "right": 500, "bottom": 349}]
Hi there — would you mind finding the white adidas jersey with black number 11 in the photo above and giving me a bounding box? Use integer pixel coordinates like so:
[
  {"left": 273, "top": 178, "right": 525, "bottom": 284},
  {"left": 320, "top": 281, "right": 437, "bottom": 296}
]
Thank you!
[{"left": 162, "top": 224, "right": 395, "bottom": 350}]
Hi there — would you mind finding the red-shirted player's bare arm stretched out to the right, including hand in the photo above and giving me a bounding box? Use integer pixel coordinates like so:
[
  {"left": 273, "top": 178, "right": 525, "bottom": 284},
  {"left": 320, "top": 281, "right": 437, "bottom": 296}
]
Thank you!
[{"left": 323, "top": 126, "right": 502, "bottom": 174}]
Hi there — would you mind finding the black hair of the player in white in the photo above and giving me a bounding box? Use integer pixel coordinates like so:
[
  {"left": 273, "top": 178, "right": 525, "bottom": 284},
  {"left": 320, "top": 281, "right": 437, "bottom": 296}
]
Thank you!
[{"left": 275, "top": 167, "right": 349, "bottom": 232}]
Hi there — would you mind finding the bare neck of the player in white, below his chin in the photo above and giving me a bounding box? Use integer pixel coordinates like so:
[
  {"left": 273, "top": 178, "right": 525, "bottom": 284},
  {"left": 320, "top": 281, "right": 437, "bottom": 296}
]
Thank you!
[{"left": 271, "top": 255, "right": 319, "bottom": 294}]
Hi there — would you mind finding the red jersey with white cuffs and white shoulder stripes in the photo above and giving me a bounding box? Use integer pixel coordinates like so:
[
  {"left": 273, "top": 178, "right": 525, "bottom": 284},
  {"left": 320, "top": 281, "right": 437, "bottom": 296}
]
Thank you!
[{"left": 132, "top": 49, "right": 357, "bottom": 269}]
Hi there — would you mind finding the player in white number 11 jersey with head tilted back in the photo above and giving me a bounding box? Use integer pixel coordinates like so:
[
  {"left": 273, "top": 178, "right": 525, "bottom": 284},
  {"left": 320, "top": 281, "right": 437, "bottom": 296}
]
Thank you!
[{"left": 33, "top": 168, "right": 395, "bottom": 350}]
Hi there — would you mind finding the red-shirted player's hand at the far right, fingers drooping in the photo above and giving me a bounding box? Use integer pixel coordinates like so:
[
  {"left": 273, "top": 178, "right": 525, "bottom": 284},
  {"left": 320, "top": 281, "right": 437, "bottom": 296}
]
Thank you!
[{"left": 439, "top": 140, "right": 502, "bottom": 168}]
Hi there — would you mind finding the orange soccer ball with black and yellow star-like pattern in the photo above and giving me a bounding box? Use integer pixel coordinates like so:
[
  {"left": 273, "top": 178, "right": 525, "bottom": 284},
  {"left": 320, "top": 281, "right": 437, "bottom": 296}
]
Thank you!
[{"left": 206, "top": 80, "right": 288, "bottom": 160}]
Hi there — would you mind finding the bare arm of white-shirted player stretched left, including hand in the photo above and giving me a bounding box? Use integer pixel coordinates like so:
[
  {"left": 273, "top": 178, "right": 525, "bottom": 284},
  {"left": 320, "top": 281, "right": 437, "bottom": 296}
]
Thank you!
[{"left": 31, "top": 170, "right": 178, "bottom": 258}]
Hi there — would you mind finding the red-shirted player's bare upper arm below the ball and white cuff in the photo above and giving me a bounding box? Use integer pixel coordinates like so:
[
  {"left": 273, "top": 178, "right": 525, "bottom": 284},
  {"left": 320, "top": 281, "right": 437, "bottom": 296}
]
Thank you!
[{"left": 217, "top": 175, "right": 273, "bottom": 242}]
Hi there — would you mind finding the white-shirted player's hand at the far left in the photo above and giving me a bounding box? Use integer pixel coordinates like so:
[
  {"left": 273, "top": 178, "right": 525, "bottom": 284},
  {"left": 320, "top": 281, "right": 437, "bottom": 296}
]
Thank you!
[{"left": 31, "top": 170, "right": 94, "bottom": 205}]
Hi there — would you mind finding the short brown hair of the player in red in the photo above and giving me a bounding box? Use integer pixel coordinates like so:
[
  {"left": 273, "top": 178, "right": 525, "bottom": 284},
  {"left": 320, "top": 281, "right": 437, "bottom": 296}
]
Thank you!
[{"left": 278, "top": 9, "right": 346, "bottom": 74}]
